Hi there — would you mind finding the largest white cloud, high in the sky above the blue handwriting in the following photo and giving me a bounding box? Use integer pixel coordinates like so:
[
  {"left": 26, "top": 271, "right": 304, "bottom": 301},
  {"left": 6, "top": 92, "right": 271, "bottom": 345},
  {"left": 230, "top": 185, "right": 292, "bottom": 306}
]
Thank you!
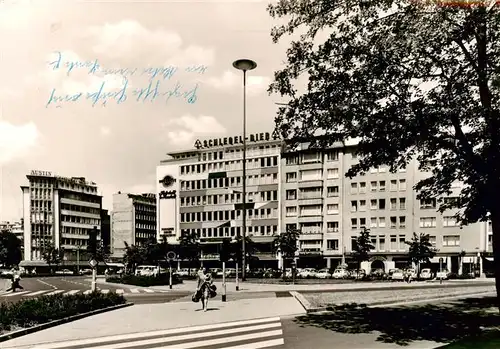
[{"left": 85, "top": 20, "right": 215, "bottom": 65}]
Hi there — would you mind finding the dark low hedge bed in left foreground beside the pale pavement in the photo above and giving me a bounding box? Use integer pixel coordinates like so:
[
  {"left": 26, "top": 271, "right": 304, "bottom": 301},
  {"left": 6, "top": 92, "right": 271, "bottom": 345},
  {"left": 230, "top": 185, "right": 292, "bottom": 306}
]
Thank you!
[{"left": 0, "top": 291, "right": 126, "bottom": 333}]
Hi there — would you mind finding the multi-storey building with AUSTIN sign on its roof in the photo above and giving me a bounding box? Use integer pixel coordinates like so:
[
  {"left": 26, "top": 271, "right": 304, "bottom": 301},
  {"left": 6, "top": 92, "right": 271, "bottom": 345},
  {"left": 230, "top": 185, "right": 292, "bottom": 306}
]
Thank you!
[{"left": 21, "top": 170, "right": 102, "bottom": 266}]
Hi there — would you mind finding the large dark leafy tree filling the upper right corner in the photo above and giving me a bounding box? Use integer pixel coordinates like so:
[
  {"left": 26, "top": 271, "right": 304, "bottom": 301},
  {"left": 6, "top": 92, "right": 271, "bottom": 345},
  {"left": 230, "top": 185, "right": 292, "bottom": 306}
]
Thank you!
[{"left": 268, "top": 0, "right": 500, "bottom": 307}]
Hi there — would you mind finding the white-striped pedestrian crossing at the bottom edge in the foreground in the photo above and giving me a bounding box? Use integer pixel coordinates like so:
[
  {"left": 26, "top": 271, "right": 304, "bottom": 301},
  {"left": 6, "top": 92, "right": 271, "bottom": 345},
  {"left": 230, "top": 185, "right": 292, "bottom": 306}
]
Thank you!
[{"left": 30, "top": 317, "right": 285, "bottom": 349}]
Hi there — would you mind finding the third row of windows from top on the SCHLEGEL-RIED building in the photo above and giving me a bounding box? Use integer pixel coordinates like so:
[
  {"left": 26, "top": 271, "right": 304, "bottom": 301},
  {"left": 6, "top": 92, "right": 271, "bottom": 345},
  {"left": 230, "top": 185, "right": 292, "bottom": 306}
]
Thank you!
[{"left": 181, "top": 190, "right": 278, "bottom": 207}]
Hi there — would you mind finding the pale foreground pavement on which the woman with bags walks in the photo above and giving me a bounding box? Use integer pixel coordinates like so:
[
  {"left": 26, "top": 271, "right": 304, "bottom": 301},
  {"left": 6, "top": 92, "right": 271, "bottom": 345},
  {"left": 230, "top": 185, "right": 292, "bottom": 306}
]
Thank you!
[{"left": 1, "top": 297, "right": 305, "bottom": 349}]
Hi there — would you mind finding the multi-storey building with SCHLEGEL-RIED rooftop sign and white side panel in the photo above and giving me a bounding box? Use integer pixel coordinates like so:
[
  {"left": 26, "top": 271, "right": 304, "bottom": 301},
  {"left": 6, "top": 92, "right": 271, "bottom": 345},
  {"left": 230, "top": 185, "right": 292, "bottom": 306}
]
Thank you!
[{"left": 157, "top": 133, "right": 281, "bottom": 266}]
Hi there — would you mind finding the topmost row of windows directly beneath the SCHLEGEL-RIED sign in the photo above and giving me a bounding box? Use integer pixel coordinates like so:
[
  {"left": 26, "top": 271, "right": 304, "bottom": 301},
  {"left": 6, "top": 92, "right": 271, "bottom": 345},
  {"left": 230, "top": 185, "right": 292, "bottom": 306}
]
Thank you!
[{"left": 180, "top": 156, "right": 278, "bottom": 175}]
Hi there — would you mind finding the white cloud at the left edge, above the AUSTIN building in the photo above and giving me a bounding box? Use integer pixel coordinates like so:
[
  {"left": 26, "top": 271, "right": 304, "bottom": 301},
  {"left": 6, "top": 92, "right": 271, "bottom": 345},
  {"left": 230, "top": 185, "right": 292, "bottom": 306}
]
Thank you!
[{"left": 0, "top": 121, "right": 40, "bottom": 165}]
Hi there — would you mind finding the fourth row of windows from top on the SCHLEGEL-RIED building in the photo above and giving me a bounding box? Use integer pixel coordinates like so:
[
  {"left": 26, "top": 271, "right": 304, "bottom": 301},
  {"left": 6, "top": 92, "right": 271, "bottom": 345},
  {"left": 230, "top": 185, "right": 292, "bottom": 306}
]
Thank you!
[{"left": 181, "top": 208, "right": 278, "bottom": 223}]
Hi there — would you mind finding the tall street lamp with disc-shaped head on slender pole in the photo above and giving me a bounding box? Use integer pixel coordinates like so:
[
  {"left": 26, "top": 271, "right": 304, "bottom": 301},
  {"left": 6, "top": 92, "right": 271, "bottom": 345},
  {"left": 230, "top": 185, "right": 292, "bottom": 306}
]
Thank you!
[{"left": 233, "top": 59, "right": 257, "bottom": 281}]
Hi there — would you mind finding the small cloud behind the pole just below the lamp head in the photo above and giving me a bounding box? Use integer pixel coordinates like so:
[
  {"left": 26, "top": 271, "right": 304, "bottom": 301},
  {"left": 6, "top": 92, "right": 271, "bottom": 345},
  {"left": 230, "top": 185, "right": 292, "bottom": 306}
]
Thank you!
[{"left": 205, "top": 70, "right": 271, "bottom": 95}]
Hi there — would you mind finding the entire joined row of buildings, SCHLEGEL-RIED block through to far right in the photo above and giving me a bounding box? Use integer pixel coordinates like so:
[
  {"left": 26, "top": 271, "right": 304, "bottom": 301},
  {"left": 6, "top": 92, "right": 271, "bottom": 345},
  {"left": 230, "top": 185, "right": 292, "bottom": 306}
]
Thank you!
[{"left": 157, "top": 134, "right": 491, "bottom": 273}]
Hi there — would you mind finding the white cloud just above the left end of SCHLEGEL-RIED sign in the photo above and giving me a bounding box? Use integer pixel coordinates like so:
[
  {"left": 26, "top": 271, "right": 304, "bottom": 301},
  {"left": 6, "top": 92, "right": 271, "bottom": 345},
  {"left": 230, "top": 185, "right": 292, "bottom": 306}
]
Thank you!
[{"left": 164, "top": 114, "right": 226, "bottom": 147}]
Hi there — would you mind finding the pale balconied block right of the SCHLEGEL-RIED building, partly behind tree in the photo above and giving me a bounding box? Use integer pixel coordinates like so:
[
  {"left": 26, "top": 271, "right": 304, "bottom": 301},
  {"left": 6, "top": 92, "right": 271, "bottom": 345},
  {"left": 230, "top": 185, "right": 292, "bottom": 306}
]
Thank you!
[{"left": 281, "top": 143, "right": 486, "bottom": 272}]
